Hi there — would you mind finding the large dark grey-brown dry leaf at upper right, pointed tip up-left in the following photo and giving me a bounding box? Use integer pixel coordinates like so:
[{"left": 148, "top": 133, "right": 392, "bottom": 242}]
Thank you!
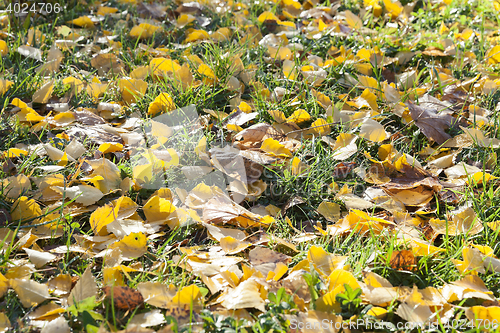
[{"left": 406, "top": 101, "right": 453, "bottom": 145}]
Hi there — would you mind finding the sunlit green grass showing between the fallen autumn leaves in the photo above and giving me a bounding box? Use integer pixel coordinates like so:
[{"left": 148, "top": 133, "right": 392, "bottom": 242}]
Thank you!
[{"left": 0, "top": 0, "right": 500, "bottom": 332}]
